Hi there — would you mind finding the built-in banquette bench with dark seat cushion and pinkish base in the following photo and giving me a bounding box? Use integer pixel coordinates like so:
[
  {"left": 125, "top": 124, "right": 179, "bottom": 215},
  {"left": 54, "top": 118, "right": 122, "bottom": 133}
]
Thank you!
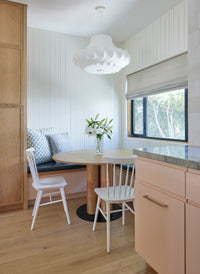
[{"left": 28, "top": 161, "right": 86, "bottom": 205}]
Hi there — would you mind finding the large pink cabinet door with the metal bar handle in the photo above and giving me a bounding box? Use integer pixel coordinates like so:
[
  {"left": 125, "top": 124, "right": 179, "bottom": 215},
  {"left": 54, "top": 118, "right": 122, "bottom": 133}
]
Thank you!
[{"left": 135, "top": 181, "right": 185, "bottom": 274}]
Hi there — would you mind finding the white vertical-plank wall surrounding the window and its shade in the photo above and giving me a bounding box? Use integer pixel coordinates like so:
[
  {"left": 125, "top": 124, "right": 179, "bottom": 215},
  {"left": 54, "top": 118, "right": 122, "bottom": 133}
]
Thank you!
[{"left": 120, "top": 0, "right": 188, "bottom": 149}]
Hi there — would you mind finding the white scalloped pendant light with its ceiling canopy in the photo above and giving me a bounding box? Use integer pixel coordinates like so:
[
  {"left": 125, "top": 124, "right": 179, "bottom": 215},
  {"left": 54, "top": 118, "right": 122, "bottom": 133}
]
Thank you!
[{"left": 73, "top": 6, "right": 130, "bottom": 74}]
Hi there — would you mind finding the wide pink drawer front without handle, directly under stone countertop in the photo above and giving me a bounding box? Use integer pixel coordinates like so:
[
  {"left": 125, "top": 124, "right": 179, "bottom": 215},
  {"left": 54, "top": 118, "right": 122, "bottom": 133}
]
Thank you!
[{"left": 136, "top": 158, "right": 187, "bottom": 197}]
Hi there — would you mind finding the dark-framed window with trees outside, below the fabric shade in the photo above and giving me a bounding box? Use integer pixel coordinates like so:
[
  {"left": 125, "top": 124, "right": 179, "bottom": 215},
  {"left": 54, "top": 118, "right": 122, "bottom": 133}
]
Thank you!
[{"left": 131, "top": 89, "right": 188, "bottom": 142}]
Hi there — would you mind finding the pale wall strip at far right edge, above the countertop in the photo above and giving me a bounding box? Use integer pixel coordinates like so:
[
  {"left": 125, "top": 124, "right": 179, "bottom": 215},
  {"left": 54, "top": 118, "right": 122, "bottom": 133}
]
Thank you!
[{"left": 188, "top": 0, "right": 200, "bottom": 146}]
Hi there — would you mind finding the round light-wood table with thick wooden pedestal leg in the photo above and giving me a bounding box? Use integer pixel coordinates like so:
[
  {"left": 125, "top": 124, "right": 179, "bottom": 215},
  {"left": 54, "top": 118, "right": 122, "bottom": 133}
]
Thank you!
[{"left": 53, "top": 149, "right": 134, "bottom": 221}]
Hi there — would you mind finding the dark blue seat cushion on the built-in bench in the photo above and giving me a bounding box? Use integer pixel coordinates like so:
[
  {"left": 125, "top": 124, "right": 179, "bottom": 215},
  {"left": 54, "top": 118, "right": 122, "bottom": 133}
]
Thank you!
[{"left": 28, "top": 161, "right": 86, "bottom": 173}]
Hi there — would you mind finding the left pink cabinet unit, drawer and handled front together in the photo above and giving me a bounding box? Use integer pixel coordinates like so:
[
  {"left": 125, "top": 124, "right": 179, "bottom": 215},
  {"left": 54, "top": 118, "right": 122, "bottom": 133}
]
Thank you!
[{"left": 135, "top": 157, "right": 187, "bottom": 274}]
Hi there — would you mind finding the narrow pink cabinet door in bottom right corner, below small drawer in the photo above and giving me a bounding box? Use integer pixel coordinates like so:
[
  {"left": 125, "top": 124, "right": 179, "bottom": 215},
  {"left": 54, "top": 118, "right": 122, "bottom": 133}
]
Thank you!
[{"left": 186, "top": 204, "right": 200, "bottom": 274}]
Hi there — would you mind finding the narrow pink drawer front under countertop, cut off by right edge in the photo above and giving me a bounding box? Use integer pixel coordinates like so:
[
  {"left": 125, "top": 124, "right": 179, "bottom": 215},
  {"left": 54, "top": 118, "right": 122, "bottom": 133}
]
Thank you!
[{"left": 186, "top": 172, "right": 200, "bottom": 204}]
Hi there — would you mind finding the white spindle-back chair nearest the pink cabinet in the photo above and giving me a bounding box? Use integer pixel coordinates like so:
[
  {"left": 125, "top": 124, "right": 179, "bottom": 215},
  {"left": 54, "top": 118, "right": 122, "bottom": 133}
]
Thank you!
[{"left": 92, "top": 156, "right": 135, "bottom": 253}]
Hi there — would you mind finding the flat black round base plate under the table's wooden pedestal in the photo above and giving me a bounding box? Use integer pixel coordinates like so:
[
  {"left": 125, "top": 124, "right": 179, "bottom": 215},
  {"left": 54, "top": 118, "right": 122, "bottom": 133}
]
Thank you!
[{"left": 76, "top": 204, "right": 122, "bottom": 223}]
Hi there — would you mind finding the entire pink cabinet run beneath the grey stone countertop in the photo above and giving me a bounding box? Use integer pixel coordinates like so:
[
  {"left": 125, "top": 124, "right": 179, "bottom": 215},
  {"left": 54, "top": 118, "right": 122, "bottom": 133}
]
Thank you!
[{"left": 135, "top": 157, "right": 200, "bottom": 274}]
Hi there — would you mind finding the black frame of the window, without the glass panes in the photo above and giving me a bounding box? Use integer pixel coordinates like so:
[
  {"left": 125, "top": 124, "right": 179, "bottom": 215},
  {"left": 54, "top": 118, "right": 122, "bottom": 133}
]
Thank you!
[{"left": 128, "top": 88, "right": 188, "bottom": 142}]
